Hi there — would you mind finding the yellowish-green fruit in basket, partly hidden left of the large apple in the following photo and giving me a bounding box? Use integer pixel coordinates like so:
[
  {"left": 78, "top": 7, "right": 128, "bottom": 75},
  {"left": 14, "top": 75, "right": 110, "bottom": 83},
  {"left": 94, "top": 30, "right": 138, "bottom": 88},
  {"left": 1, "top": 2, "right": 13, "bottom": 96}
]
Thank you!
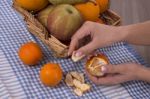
[{"left": 37, "top": 5, "right": 54, "bottom": 27}]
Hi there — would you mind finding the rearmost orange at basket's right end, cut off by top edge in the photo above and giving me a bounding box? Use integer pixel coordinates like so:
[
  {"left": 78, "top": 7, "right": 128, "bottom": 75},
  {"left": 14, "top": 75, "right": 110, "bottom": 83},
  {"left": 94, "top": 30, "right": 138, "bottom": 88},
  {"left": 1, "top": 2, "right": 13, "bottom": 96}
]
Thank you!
[{"left": 96, "top": 0, "right": 109, "bottom": 13}]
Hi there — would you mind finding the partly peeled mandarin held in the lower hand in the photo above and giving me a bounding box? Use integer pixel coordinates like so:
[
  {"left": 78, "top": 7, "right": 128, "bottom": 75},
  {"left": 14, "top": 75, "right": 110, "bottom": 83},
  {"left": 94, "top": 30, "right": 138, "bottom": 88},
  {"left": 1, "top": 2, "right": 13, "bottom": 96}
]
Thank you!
[{"left": 86, "top": 54, "right": 109, "bottom": 77}]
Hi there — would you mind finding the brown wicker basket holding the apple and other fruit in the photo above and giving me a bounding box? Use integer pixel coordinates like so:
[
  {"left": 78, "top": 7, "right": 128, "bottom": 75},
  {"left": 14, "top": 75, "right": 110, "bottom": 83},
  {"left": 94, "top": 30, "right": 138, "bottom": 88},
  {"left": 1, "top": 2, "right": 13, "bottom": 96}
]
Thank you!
[{"left": 13, "top": 0, "right": 121, "bottom": 57}]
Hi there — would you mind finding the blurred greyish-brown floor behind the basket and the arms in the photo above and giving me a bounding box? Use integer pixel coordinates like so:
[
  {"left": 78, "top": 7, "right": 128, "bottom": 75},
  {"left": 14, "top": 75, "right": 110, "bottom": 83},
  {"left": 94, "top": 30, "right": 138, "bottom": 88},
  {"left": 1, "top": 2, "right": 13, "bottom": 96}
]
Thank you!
[{"left": 110, "top": 0, "right": 150, "bottom": 64}]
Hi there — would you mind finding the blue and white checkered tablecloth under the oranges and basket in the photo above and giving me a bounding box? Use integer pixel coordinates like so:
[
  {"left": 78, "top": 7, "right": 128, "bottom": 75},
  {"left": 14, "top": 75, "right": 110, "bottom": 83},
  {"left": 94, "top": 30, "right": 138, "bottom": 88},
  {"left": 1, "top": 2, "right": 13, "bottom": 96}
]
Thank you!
[{"left": 0, "top": 0, "right": 150, "bottom": 99}]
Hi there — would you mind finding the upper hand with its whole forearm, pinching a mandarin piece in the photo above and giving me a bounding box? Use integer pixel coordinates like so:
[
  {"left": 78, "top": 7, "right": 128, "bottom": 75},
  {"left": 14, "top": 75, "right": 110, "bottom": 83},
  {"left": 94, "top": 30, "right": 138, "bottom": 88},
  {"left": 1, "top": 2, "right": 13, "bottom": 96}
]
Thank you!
[{"left": 68, "top": 21, "right": 150, "bottom": 56}]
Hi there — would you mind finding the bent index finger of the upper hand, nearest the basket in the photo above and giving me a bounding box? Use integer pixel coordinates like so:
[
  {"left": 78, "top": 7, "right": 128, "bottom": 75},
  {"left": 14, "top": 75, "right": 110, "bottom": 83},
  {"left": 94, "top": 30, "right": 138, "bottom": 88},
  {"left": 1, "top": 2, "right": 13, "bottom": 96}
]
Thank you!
[{"left": 68, "top": 24, "right": 90, "bottom": 55}]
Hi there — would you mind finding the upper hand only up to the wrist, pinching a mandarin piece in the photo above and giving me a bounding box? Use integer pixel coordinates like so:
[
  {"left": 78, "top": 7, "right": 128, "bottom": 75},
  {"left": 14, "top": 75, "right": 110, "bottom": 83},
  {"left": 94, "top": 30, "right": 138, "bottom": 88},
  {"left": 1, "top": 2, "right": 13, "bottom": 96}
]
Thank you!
[{"left": 68, "top": 21, "right": 125, "bottom": 56}]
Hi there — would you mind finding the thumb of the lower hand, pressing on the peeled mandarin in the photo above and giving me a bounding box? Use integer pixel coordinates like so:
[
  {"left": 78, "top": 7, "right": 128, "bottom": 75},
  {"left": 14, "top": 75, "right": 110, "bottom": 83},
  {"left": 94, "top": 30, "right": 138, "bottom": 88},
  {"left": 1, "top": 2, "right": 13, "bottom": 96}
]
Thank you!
[{"left": 101, "top": 65, "right": 126, "bottom": 73}]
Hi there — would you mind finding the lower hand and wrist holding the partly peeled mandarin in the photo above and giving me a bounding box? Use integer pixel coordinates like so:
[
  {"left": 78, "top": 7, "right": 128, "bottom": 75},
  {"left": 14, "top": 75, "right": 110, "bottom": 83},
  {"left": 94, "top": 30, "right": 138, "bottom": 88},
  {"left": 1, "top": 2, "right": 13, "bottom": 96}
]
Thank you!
[{"left": 86, "top": 63, "right": 150, "bottom": 85}]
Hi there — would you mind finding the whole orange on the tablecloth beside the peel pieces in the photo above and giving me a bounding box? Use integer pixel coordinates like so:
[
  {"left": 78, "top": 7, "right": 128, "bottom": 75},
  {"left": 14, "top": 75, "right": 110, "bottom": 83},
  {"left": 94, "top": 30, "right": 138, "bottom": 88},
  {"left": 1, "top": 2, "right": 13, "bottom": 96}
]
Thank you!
[{"left": 40, "top": 63, "right": 63, "bottom": 87}]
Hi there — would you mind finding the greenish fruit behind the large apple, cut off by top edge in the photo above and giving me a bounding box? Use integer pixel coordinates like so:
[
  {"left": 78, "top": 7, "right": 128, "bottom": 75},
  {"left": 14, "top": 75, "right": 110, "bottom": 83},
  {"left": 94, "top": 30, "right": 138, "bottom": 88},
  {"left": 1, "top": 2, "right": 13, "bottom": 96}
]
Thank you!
[{"left": 49, "top": 0, "right": 88, "bottom": 5}]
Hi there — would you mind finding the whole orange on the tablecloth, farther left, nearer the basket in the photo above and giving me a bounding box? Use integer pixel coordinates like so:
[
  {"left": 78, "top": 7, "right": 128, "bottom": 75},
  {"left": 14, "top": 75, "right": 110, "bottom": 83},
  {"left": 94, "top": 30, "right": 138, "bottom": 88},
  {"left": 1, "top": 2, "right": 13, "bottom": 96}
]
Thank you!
[{"left": 18, "top": 42, "right": 42, "bottom": 65}]
